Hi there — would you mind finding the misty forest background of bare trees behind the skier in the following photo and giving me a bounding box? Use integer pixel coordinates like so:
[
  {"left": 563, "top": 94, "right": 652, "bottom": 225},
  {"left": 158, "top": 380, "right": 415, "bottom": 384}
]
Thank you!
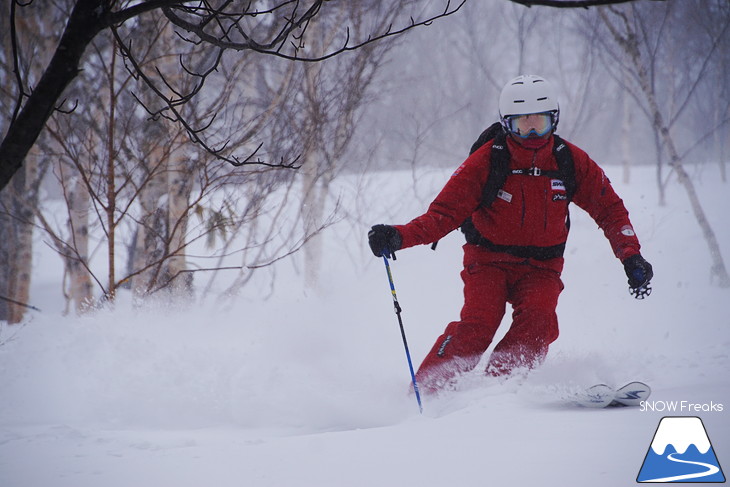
[{"left": 0, "top": 0, "right": 730, "bottom": 323}]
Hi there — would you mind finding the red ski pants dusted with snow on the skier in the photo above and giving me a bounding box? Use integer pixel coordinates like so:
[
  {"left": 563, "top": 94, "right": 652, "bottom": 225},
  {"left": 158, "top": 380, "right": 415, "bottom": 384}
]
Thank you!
[{"left": 416, "top": 262, "right": 563, "bottom": 392}]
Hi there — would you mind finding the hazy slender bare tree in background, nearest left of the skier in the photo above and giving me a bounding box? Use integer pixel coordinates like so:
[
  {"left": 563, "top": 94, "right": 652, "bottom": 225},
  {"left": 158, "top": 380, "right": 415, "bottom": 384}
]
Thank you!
[{"left": 282, "top": 0, "right": 410, "bottom": 286}]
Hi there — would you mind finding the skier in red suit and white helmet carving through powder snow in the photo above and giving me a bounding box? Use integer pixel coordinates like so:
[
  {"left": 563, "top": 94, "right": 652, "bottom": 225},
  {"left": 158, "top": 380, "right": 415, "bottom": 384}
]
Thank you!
[{"left": 368, "top": 75, "right": 653, "bottom": 393}]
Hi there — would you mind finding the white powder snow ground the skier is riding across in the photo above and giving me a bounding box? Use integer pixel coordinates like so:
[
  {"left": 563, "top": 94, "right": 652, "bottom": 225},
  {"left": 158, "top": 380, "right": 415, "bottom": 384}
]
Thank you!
[{"left": 0, "top": 167, "right": 730, "bottom": 487}]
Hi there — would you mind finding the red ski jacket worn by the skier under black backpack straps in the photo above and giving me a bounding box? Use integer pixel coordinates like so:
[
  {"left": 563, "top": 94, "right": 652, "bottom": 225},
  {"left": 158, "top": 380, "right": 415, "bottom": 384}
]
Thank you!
[{"left": 396, "top": 137, "right": 640, "bottom": 272}]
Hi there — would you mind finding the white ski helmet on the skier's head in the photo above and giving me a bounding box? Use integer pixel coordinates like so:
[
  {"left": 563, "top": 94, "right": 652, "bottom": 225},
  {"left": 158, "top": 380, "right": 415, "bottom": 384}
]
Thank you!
[{"left": 499, "top": 74, "right": 560, "bottom": 132}]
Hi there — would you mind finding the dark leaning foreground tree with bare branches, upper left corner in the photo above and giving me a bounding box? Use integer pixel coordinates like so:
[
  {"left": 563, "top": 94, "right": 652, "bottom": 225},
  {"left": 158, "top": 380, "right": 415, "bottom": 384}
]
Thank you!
[{"left": 0, "top": 0, "right": 463, "bottom": 193}]
